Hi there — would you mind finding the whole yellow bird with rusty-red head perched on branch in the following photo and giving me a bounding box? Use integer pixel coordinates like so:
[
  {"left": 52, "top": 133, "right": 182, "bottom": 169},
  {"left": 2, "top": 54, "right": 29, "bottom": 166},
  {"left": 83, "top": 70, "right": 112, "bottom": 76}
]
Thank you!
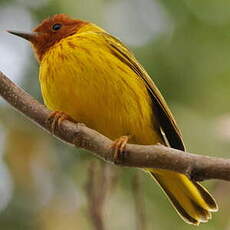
[{"left": 9, "top": 14, "right": 218, "bottom": 225}]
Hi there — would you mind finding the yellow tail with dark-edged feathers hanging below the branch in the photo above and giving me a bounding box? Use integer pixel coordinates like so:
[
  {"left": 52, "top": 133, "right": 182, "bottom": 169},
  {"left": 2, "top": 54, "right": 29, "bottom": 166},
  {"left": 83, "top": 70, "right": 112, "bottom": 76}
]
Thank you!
[{"left": 148, "top": 169, "right": 218, "bottom": 225}]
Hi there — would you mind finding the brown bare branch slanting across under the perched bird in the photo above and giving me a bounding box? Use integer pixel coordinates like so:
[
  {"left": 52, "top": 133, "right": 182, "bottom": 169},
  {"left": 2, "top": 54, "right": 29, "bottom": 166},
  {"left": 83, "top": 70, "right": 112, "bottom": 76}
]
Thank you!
[{"left": 0, "top": 72, "right": 230, "bottom": 181}]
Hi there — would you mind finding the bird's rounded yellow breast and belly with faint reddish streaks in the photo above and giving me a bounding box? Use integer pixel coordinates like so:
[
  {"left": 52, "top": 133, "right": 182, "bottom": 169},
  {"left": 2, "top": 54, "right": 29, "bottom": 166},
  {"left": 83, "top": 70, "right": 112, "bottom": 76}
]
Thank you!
[{"left": 40, "top": 33, "right": 162, "bottom": 143}]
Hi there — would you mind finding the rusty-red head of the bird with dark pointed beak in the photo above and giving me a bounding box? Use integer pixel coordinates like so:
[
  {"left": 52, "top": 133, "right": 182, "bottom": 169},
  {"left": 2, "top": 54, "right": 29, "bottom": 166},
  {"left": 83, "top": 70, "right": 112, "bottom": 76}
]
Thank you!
[{"left": 8, "top": 14, "right": 88, "bottom": 61}]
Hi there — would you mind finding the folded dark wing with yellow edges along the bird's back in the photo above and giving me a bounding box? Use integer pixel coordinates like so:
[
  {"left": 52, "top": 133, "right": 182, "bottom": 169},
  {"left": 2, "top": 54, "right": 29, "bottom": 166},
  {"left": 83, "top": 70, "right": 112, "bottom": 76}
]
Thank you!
[{"left": 99, "top": 32, "right": 185, "bottom": 150}]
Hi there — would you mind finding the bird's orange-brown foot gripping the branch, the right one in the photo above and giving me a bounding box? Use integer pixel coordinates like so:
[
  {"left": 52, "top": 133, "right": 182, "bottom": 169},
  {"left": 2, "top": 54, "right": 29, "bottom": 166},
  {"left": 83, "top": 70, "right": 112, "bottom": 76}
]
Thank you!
[{"left": 112, "top": 136, "right": 129, "bottom": 164}]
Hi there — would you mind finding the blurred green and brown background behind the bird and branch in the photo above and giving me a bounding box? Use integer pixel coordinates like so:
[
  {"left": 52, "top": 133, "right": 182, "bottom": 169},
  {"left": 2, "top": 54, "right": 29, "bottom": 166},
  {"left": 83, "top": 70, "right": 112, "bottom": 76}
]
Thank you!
[{"left": 0, "top": 0, "right": 230, "bottom": 230}]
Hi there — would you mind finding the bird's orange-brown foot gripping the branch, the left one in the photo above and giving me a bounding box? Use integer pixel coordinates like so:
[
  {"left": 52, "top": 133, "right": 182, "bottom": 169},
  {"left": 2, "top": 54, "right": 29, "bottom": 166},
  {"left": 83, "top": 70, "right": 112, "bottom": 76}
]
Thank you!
[{"left": 47, "top": 111, "right": 76, "bottom": 133}]
